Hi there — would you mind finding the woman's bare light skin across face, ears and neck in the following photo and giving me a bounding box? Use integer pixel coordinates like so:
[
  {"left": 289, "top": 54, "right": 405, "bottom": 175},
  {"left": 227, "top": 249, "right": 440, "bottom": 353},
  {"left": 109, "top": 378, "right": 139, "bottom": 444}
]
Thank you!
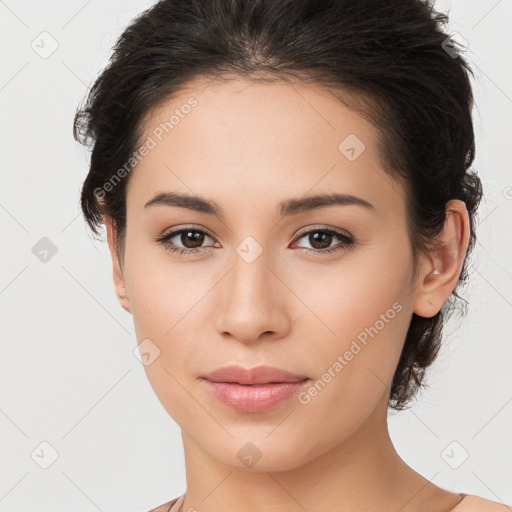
[{"left": 105, "top": 79, "right": 469, "bottom": 512}]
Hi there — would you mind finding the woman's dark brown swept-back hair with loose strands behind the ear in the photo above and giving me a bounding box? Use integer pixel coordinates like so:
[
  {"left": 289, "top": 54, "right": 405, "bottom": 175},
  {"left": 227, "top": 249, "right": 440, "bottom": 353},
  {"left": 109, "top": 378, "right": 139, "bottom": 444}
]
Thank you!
[{"left": 73, "top": 0, "right": 482, "bottom": 409}]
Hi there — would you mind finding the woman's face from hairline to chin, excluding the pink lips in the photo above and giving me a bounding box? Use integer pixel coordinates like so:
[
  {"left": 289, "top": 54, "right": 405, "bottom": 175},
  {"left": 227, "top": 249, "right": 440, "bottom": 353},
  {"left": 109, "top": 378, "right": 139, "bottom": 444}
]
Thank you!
[{"left": 107, "top": 80, "right": 432, "bottom": 470}]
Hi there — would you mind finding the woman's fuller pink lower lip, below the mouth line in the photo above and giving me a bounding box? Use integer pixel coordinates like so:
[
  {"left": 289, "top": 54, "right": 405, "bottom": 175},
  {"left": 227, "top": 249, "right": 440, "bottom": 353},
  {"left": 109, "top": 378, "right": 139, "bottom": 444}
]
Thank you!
[{"left": 203, "top": 379, "right": 309, "bottom": 413}]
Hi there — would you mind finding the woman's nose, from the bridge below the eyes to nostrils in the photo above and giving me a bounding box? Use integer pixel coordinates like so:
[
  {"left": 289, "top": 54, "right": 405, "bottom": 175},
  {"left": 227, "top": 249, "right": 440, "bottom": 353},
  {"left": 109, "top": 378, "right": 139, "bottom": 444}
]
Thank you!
[{"left": 216, "top": 244, "right": 291, "bottom": 343}]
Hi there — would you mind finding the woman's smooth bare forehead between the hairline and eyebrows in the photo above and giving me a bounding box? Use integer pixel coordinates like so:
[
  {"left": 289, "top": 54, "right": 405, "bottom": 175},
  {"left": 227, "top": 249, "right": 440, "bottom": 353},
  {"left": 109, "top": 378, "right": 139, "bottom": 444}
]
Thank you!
[{"left": 127, "top": 79, "right": 401, "bottom": 218}]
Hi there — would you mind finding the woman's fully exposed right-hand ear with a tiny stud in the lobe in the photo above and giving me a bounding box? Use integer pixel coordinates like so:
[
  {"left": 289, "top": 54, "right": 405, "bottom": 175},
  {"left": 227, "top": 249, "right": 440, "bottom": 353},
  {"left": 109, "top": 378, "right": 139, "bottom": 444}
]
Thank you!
[{"left": 414, "top": 199, "right": 470, "bottom": 318}]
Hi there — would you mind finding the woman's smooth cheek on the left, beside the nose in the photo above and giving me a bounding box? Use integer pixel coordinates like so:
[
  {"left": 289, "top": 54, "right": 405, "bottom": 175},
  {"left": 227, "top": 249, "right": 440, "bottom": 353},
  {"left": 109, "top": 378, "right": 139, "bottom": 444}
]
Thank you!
[{"left": 125, "top": 241, "right": 208, "bottom": 404}]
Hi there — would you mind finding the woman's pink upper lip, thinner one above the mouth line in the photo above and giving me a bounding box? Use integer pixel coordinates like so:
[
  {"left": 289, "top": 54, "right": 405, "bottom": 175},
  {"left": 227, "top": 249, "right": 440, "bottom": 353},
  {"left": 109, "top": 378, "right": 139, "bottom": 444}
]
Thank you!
[{"left": 201, "top": 365, "right": 308, "bottom": 384}]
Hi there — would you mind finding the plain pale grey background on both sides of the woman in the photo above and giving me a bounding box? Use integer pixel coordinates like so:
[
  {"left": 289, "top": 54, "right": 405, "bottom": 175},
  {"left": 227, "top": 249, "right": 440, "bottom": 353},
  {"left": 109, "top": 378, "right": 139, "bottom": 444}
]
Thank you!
[{"left": 0, "top": 0, "right": 512, "bottom": 512}]
